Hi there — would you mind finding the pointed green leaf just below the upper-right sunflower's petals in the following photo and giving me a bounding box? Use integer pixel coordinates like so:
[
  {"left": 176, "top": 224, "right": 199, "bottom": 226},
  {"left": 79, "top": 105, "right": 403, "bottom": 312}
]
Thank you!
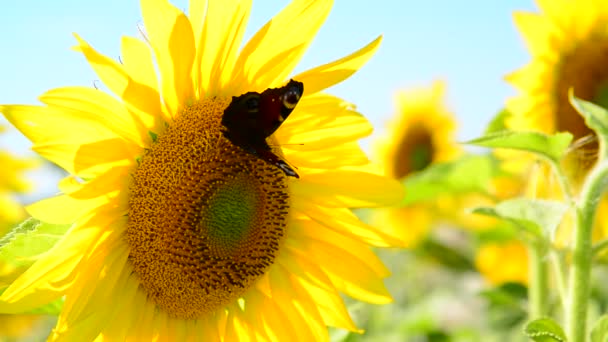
[{"left": 466, "top": 131, "right": 572, "bottom": 162}]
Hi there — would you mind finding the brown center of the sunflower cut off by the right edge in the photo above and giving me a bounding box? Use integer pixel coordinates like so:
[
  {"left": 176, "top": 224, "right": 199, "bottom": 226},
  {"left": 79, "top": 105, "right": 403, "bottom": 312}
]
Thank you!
[{"left": 555, "top": 36, "right": 608, "bottom": 181}]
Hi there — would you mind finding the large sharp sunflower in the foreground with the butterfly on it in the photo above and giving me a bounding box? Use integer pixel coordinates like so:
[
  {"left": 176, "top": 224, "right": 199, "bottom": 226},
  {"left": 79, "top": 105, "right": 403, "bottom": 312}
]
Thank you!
[{"left": 0, "top": 0, "right": 403, "bottom": 341}]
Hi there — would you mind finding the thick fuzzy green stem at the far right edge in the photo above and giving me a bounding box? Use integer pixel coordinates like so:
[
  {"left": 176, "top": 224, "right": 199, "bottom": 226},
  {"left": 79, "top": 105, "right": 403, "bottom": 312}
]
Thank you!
[{"left": 566, "top": 161, "right": 608, "bottom": 342}]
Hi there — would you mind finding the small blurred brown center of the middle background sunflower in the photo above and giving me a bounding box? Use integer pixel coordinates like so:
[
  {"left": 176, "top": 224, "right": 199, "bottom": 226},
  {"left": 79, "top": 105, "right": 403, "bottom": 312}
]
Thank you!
[{"left": 393, "top": 125, "right": 435, "bottom": 179}]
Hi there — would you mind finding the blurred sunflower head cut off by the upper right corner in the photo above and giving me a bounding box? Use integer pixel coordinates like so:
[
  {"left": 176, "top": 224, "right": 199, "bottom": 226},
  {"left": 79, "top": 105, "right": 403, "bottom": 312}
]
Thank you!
[{"left": 507, "top": 0, "right": 608, "bottom": 182}]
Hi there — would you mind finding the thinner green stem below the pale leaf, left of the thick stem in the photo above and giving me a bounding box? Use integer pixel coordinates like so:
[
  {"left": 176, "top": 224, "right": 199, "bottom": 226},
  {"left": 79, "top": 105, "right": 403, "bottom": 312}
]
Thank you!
[{"left": 528, "top": 241, "right": 548, "bottom": 320}]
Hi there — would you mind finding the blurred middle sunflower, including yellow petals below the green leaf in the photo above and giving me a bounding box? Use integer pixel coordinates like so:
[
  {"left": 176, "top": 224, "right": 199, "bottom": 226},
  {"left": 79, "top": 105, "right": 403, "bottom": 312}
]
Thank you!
[{"left": 372, "top": 81, "right": 460, "bottom": 247}]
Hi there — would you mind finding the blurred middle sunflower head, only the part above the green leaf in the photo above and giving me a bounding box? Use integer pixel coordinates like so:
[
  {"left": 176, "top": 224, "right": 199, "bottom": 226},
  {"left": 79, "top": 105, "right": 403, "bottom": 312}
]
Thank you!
[{"left": 375, "top": 81, "right": 460, "bottom": 179}]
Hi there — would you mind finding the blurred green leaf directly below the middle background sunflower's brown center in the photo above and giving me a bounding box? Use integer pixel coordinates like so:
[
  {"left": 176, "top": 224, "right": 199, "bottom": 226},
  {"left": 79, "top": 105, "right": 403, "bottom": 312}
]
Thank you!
[{"left": 402, "top": 155, "right": 499, "bottom": 205}]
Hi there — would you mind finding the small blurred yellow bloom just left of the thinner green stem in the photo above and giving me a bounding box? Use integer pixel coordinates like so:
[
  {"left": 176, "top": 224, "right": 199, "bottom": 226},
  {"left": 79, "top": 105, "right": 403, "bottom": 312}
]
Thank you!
[{"left": 475, "top": 240, "right": 528, "bottom": 285}]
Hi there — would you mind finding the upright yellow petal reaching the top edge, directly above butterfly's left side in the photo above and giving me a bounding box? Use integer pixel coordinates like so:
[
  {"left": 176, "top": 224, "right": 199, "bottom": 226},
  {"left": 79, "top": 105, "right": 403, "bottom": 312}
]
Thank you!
[{"left": 195, "top": 0, "right": 251, "bottom": 96}]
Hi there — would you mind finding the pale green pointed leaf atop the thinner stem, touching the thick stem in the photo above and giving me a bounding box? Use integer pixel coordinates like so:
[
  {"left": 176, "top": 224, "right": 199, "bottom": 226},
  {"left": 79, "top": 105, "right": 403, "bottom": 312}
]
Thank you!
[{"left": 473, "top": 197, "right": 568, "bottom": 240}]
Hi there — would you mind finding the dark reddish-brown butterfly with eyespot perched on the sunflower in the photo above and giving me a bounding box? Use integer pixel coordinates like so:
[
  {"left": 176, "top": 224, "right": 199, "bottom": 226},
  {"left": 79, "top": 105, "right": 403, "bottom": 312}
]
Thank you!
[{"left": 222, "top": 80, "right": 304, "bottom": 178}]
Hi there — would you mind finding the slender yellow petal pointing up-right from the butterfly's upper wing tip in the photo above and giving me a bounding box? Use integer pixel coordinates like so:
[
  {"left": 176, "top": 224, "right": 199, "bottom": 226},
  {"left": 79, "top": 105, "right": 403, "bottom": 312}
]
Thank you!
[{"left": 293, "top": 37, "right": 382, "bottom": 95}]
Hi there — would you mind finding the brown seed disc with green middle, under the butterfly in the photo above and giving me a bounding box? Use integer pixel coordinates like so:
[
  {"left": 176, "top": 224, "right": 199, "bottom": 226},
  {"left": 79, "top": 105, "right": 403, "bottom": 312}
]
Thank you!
[{"left": 126, "top": 99, "right": 289, "bottom": 319}]
